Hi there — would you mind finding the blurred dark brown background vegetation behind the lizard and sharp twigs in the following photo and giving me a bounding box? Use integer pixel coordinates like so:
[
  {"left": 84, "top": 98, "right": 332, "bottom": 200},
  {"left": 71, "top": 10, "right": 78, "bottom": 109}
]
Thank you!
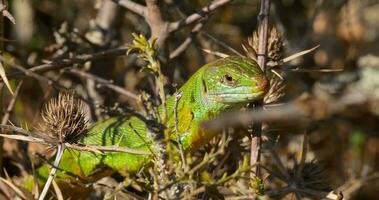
[{"left": 0, "top": 0, "right": 379, "bottom": 199}]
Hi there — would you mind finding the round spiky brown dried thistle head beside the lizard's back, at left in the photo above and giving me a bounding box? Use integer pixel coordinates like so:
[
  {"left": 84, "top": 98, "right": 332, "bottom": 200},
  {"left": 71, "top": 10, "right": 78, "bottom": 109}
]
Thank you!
[{"left": 38, "top": 93, "right": 88, "bottom": 144}]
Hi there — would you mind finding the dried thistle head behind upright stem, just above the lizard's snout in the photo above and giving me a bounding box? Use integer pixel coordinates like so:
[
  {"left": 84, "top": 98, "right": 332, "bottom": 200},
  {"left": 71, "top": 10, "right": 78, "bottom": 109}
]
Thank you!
[{"left": 244, "top": 26, "right": 284, "bottom": 62}]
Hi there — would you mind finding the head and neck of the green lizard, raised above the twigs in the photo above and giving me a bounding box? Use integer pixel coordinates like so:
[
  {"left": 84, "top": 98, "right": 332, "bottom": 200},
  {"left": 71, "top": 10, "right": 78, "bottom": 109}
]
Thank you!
[{"left": 169, "top": 57, "right": 269, "bottom": 150}]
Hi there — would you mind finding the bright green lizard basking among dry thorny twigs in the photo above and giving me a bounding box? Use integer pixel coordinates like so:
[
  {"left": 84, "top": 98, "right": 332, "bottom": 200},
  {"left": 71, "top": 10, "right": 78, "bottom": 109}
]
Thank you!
[{"left": 25, "top": 57, "right": 268, "bottom": 198}]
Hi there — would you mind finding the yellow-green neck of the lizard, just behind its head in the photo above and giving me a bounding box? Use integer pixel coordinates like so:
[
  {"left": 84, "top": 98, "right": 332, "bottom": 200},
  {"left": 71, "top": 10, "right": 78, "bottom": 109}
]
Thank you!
[{"left": 164, "top": 71, "right": 230, "bottom": 152}]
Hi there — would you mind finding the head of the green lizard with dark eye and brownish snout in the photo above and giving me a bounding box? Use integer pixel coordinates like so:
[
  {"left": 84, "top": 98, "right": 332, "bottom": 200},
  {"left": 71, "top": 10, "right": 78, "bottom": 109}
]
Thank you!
[{"left": 202, "top": 57, "right": 269, "bottom": 105}]
